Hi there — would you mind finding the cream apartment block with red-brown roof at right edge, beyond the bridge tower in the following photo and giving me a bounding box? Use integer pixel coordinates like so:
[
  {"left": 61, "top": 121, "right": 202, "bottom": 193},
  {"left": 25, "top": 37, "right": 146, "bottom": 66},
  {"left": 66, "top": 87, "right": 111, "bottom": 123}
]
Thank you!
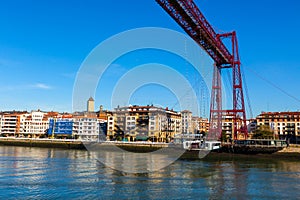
[{"left": 256, "top": 112, "right": 300, "bottom": 143}]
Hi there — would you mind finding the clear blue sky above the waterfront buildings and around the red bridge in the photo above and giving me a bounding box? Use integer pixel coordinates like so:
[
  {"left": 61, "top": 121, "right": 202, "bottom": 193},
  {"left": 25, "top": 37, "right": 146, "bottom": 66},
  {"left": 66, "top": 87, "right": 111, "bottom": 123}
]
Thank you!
[{"left": 0, "top": 0, "right": 300, "bottom": 116}]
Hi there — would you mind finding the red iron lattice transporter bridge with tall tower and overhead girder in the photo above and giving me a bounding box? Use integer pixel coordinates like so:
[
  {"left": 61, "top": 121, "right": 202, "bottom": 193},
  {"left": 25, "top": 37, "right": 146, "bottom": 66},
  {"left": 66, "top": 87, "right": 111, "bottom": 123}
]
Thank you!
[{"left": 156, "top": 0, "right": 248, "bottom": 140}]
